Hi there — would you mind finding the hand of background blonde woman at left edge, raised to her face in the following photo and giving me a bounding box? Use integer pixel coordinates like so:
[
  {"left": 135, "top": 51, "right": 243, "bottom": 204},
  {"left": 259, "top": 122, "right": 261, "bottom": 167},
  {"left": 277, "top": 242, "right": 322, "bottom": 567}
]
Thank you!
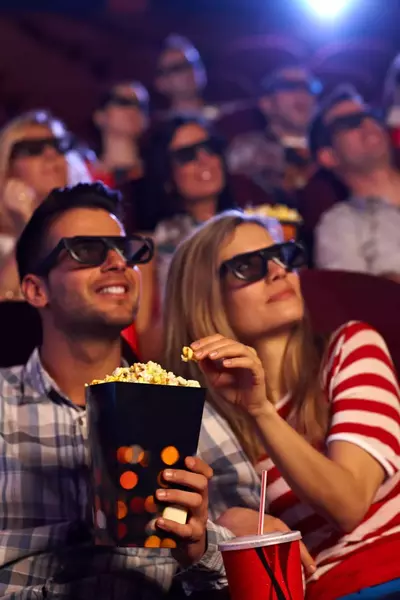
[{"left": 2, "top": 179, "right": 37, "bottom": 237}]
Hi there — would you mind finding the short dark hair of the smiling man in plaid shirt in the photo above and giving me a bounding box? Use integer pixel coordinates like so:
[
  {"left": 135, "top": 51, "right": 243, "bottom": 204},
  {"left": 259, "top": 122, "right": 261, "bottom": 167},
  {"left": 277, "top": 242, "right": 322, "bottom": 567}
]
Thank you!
[{"left": 16, "top": 181, "right": 121, "bottom": 281}]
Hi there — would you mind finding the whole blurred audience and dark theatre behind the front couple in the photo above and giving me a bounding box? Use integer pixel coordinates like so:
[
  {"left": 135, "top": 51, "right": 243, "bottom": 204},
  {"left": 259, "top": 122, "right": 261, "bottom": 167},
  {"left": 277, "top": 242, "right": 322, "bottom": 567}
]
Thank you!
[{"left": 0, "top": 0, "right": 400, "bottom": 358}]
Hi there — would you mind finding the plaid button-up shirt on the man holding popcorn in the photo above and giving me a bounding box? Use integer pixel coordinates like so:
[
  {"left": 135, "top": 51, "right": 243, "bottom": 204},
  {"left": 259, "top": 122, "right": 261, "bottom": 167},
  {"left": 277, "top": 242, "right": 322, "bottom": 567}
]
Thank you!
[{"left": 0, "top": 350, "right": 260, "bottom": 600}]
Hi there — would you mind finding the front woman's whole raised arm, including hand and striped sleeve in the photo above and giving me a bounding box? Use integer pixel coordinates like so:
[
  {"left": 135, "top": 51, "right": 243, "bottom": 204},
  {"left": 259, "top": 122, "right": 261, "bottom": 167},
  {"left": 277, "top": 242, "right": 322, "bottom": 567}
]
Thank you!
[{"left": 192, "top": 323, "right": 400, "bottom": 532}]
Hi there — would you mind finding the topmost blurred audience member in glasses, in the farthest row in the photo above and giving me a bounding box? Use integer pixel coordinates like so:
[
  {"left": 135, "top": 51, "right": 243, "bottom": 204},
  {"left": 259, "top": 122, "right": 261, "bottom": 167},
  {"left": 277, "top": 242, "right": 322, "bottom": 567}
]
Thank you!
[{"left": 155, "top": 35, "right": 217, "bottom": 120}]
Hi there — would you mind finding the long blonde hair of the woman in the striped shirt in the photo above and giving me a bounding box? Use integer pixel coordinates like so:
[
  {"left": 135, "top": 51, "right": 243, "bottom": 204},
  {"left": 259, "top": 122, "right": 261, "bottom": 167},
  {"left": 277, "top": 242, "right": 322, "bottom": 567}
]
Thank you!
[{"left": 164, "top": 211, "right": 328, "bottom": 463}]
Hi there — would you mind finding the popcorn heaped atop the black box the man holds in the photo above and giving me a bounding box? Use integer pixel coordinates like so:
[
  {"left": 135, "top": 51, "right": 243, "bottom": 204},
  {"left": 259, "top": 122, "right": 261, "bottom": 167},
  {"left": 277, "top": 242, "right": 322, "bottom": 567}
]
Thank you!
[{"left": 90, "top": 361, "right": 200, "bottom": 387}]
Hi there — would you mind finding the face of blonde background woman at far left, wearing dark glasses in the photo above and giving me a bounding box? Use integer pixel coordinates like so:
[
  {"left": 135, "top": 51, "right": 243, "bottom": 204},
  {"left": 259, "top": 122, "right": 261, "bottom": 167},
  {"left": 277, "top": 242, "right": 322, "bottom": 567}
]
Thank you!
[{"left": 9, "top": 125, "right": 68, "bottom": 200}]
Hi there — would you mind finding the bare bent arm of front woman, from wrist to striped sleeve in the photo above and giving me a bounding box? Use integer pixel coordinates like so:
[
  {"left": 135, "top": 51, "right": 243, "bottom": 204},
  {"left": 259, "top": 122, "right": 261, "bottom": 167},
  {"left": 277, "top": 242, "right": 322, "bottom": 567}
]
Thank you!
[{"left": 256, "top": 409, "right": 385, "bottom": 533}]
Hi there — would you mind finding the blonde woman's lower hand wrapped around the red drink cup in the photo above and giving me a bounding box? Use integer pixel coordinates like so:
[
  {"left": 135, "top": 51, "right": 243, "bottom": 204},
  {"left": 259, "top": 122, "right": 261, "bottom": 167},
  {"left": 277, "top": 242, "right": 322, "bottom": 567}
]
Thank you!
[{"left": 216, "top": 507, "right": 317, "bottom": 576}]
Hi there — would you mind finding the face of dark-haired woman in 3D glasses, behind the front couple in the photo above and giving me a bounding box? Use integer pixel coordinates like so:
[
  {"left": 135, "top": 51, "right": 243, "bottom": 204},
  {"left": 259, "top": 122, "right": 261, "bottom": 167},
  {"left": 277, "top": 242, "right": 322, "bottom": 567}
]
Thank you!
[{"left": 169, "top": 123, "right": 225, "bottom": 203}]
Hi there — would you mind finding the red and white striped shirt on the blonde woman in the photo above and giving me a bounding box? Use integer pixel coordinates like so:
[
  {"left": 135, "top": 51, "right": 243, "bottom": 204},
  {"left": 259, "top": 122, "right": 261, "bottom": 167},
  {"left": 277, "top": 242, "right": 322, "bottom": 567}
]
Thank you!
[{"left": 257, "top": 322, "right": 400, "bottom": 598}]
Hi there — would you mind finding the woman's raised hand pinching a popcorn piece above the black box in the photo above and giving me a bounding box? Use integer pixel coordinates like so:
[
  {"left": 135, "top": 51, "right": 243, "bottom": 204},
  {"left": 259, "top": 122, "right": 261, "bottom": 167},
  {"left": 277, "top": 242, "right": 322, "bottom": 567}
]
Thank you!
[{"left": 191, "top": 335, "right": 273, "bottom": 417}]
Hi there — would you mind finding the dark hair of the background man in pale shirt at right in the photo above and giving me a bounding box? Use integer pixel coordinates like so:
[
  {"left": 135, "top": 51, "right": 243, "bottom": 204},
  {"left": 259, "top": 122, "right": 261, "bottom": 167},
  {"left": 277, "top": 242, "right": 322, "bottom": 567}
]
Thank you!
[{"left": 308, "top": 85, "right": 363, "bottom": 161}]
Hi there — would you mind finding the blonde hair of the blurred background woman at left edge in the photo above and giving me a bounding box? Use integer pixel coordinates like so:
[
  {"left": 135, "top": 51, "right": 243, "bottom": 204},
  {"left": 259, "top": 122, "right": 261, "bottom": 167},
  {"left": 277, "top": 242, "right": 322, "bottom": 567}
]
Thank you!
[{"left": 0, "top": 110, "right": 91, "bottom": 230}]
